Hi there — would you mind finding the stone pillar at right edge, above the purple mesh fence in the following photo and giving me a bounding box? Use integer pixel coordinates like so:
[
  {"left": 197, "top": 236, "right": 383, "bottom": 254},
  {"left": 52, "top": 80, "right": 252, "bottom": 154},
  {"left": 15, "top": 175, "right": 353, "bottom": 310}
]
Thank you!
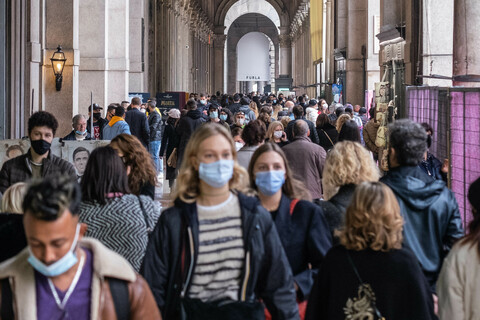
[{"left": 453, "top": 0, "right": 480, "bottom": 87}]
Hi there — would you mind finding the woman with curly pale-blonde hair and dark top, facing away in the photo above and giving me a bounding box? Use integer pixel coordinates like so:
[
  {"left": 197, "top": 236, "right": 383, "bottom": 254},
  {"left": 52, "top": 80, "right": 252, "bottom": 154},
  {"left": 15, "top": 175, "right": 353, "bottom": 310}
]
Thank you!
[{"left": 318, "top": 141, "right": 380, "bottom": 243}]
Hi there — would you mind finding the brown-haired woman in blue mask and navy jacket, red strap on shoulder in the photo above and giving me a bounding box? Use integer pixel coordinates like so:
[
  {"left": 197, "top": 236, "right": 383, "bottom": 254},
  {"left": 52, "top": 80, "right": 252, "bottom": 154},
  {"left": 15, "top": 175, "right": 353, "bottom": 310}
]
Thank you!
[{"left": 248, "top": 143, "right": 331, "bottom": 315}]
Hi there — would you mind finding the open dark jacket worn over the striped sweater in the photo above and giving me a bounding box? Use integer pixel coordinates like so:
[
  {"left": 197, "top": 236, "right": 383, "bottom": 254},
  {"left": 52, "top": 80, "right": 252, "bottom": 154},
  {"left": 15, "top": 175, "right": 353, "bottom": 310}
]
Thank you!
[{"left": 141, "top": 193, "right": 299, "bottom": 320}]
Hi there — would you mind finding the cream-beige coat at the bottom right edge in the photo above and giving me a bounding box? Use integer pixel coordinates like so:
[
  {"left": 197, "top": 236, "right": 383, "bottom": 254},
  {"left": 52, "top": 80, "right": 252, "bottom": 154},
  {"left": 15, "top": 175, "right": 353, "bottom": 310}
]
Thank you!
[{"left": 437, "top": 242, "right": 480, "bottom": 320}]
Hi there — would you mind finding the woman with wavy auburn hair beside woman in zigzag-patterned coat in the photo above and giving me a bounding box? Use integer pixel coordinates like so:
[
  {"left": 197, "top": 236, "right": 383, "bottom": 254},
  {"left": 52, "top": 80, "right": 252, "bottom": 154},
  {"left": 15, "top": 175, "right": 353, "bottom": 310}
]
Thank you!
[{"left": 110, "top": 133, "right": 157, "bottom": 200}]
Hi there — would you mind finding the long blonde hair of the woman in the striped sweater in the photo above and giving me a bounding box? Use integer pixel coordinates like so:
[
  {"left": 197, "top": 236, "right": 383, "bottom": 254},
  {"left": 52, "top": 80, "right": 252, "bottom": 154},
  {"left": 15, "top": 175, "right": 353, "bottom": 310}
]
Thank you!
[{"left": 173, "top": 123, "right": 248, "bottom": 203}]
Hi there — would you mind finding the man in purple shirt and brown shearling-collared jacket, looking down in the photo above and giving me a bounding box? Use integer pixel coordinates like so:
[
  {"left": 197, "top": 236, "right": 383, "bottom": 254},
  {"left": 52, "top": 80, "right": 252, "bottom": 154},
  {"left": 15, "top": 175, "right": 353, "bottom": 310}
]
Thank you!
[{"left": 0, "top": 176, "right": 162, "bottom": 320}]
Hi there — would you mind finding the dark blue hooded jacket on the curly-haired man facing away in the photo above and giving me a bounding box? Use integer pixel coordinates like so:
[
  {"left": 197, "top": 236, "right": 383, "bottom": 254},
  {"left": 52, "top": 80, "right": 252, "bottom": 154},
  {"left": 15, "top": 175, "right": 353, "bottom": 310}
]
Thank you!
[{"left": 380, "top": 166, "right": 464, "bottom": 290}]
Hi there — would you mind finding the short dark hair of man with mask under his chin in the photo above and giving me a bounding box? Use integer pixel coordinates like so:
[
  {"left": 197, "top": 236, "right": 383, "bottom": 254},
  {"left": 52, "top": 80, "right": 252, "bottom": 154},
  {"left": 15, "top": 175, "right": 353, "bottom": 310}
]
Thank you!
[{"left": 23, "top": 175, "right": 81, "bottom": 221}]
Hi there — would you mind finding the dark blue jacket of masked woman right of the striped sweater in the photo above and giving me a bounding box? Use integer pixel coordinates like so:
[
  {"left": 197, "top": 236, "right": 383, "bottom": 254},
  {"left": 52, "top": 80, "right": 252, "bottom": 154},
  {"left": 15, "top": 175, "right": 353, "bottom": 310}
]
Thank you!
[{"left": 273, "top": 195, "right": 332, "bottom": 300}]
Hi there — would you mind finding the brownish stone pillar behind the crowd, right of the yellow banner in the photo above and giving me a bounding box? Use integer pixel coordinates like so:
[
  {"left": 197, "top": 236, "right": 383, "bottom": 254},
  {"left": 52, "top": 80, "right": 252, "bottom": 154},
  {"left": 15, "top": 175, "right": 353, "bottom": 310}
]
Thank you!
[{"left": 345, "top": 0, "right": 368, "bottom": 104}]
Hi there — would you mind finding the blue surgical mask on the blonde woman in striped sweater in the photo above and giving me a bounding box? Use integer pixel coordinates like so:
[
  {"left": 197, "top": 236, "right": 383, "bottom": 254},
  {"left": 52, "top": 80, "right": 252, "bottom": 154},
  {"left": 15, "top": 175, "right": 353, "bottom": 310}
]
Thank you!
[{"left": 198, "top": 160, "right": 234, "bottom": 188}]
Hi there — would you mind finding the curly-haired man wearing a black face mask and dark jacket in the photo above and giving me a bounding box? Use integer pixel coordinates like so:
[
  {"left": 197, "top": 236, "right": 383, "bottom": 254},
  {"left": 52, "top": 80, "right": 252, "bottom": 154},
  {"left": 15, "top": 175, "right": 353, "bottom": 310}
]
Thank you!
[{"left": 0, "top": 111, "right": 77, "bottom": 194}]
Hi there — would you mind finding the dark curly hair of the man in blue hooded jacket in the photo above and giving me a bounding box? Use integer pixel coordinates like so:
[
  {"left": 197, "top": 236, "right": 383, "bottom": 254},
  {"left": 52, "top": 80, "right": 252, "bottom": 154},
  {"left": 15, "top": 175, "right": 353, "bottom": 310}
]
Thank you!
[{"left": 388, "top": 119, "right": 427, "bottom": 166}]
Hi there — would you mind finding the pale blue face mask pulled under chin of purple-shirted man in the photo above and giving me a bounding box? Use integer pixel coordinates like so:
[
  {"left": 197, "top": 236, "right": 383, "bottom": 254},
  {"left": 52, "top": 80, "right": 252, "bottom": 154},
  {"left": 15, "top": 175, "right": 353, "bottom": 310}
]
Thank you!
[{"left": 28, "top": 224, "right": 80, "bottom": 278}]
